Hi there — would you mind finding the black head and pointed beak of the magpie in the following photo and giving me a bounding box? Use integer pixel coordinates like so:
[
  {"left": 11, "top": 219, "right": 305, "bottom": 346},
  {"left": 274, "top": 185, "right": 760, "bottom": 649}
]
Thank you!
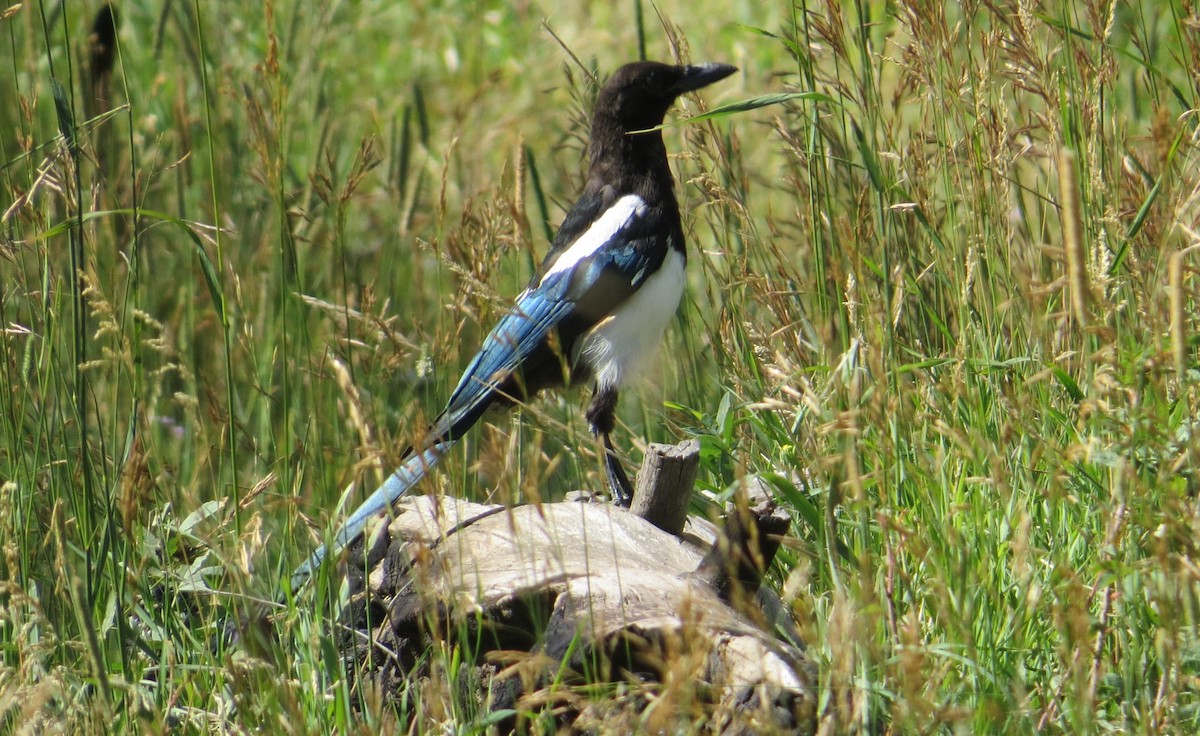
[{"left": 596, "top": 61, "right": 738, "bottom": 132}]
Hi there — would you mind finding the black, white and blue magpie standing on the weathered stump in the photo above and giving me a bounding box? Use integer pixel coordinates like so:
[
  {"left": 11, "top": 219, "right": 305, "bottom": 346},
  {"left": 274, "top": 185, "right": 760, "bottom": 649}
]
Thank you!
[{"left": 292, "top": 61, "right": 737, "bottom": 590}]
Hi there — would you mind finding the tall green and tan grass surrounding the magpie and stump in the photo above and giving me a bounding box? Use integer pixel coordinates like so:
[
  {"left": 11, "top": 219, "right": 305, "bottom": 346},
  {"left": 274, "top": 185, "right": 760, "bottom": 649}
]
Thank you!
[{"left": 0, "top": 0, "right": 1200, "bottom": 734}]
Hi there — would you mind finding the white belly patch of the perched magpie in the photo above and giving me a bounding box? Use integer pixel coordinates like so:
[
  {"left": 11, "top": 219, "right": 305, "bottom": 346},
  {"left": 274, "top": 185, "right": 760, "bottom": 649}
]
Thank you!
[{"left": 576, "top": 249, "right": 684, "bottom": 388}]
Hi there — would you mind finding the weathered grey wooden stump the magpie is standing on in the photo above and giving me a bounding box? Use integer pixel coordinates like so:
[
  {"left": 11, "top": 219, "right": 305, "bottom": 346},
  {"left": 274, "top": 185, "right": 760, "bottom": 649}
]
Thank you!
[{"left": 343, "top": 443, "right": 815, "bottom": 732}]
